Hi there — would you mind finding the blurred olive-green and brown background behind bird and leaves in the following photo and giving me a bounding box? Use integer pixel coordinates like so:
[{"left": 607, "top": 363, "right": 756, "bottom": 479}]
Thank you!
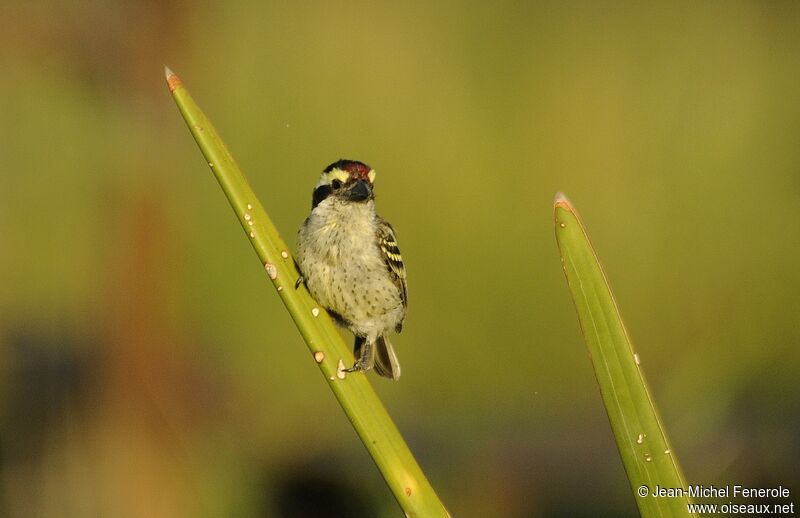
[{"left": 0, "top": 0, "right": 800, "bottom": 517}]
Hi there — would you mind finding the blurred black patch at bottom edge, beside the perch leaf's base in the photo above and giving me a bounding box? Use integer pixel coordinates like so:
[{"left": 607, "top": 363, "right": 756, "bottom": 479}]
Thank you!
[{"left": 263, "top": 459, "right": 376, "bottom": 518}]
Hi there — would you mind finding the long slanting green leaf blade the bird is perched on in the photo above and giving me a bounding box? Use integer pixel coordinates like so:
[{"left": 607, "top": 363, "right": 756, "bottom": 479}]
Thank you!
[{"left": 165, "top": 68, "right": 449, "bottom": 517}]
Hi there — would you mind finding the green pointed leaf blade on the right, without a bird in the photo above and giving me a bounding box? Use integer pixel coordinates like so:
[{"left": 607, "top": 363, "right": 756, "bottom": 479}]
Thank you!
[{"left": 554, "top": 195, "right": 690, "bottom": 517}]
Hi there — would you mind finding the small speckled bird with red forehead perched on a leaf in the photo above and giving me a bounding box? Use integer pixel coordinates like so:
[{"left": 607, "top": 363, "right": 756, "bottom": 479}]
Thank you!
[{"left": 297, "top": 159, "right": 408, "bottom": 380}]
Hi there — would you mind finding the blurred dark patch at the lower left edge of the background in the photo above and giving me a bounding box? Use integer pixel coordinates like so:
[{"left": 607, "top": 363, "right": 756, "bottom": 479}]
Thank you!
[{"left": 0, "top": 320, "right": 96, "bottom": 516}]
